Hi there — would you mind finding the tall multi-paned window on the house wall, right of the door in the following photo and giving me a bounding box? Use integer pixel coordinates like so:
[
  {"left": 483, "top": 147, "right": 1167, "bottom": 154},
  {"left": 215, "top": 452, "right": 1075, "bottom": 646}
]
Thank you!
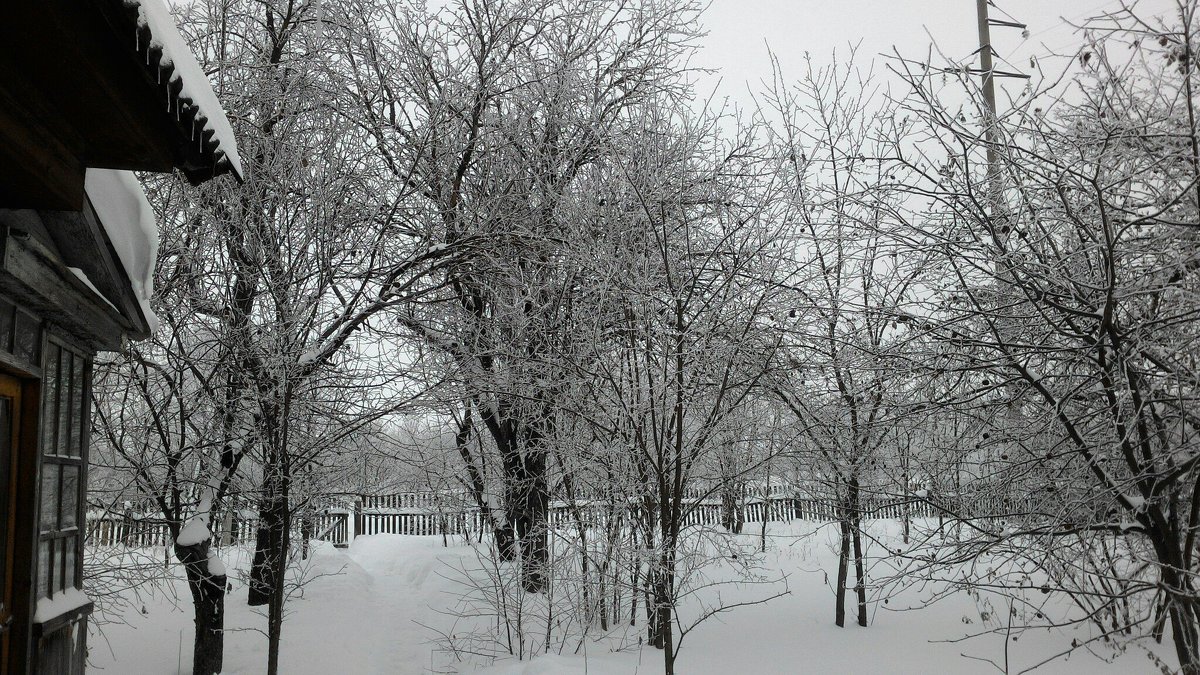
[{"left": 37, "top": 341, "right": 90, "bottom": 597}]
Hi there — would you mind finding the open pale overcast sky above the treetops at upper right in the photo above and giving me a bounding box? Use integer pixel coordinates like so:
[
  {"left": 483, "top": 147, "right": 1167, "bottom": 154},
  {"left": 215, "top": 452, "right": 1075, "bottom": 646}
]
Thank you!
[{"left": 696, "top": 0, "right": 1175, "bottom": 100}]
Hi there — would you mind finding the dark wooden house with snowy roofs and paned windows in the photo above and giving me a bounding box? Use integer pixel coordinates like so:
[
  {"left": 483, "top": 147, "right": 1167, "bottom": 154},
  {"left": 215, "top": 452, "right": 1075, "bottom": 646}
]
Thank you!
[{"left": 0, "top": 0, "right": 240, "bottom": 675}]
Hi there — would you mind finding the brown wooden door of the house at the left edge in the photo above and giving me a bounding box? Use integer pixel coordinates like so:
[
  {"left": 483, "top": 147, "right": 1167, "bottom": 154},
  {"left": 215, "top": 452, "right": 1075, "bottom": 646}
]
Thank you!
[{"left": 0, "top": 375, "right": 20, "bottom": 675}]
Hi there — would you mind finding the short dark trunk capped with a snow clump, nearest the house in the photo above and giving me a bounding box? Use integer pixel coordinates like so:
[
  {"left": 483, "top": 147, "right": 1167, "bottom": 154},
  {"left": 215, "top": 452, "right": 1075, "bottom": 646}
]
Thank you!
[{"left": 175, "top": 539, "right": 227, "bottom": 675}]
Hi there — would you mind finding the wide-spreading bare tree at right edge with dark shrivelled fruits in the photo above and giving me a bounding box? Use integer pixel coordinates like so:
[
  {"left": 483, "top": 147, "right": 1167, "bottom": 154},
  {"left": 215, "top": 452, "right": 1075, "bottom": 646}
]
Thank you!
[{"left": 900, "top": 1, "right": 1200, "bottom": 673}]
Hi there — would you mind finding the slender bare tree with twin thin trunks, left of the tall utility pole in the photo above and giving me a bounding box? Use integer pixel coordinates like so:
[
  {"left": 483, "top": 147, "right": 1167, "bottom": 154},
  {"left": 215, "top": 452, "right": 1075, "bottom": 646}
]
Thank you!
[{"left": 764, "top": 54, "right": 924, "bottom": 626}]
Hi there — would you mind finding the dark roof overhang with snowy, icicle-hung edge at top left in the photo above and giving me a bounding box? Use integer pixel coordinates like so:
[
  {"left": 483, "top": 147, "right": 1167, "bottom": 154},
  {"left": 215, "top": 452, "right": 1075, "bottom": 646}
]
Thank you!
[{"left": 0, "top": 0, "right": 240, "bottom": 210}]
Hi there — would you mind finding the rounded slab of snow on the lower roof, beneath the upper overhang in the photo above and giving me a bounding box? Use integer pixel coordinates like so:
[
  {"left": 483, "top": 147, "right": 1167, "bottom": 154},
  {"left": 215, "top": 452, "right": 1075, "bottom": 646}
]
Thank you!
[{"left": 83, "top": 168, "right": 158, "bottom": 330}]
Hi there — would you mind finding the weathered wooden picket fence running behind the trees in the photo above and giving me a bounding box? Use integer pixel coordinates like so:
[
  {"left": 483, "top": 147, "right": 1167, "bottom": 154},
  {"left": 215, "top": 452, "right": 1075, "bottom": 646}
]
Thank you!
[{"left": 88, "top": 489, "right": 969, "bottom": 548}]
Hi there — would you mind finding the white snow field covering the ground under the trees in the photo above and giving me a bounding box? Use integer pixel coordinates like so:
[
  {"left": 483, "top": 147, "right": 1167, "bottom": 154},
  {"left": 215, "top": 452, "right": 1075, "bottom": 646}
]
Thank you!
[{"left": 89, "top": 522, "right": 1174, "bottom": 675}]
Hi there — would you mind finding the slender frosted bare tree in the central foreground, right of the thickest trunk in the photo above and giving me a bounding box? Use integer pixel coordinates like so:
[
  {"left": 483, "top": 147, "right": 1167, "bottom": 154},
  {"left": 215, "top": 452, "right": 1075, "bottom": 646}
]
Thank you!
[{"left": 576, "top": 99, "right": 792, "bottom": 673}]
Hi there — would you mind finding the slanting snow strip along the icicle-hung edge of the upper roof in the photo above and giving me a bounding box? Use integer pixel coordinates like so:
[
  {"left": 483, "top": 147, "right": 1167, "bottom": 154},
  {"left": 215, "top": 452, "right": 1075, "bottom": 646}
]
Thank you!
[{"left": 124, "top": 0, "right": 242, "bottom": 177}]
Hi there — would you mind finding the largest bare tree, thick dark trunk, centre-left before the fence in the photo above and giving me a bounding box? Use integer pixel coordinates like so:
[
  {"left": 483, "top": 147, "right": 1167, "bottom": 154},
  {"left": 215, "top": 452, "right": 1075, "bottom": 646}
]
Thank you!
[{"left": 355, "top": 0, "right": 710, "bottom": 592}]
